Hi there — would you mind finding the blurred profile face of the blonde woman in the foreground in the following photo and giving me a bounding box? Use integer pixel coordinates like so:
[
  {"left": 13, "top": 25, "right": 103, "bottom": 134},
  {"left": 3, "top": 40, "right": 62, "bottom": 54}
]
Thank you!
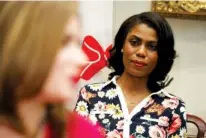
[{"left": 38, "top": 17, "right": 87, "bottom": 103}]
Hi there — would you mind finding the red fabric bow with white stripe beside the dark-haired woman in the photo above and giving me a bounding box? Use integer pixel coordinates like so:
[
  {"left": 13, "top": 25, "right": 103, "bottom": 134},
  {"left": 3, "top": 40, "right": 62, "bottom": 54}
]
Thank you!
[{"left": 74, "top": 36, "right": 112, "bottom": 83}]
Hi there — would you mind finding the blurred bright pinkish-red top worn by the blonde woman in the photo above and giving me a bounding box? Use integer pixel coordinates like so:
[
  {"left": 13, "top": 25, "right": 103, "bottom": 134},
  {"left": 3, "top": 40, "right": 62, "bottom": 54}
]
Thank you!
[{"left": 45, "top": 114, "right": 105, "bottom": 138}]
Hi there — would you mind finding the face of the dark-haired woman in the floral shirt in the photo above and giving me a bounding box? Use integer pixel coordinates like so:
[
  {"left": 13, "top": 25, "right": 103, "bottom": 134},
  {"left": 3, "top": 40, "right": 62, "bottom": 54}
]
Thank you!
[{"left": 123, "top": 23, "right": 158, "bottom": 78}]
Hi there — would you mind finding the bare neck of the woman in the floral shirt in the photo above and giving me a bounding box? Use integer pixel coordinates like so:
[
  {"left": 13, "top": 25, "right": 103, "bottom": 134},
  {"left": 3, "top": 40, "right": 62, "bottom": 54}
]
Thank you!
[{"left": 117, "top": 72, "right": 150, "bottom": 95}]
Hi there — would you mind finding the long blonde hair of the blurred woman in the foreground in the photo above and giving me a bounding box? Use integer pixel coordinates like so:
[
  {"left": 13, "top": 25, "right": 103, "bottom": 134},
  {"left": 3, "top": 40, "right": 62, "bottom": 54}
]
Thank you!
[{"left": 0, "top": 2, "right": 77, "bottom": 138}]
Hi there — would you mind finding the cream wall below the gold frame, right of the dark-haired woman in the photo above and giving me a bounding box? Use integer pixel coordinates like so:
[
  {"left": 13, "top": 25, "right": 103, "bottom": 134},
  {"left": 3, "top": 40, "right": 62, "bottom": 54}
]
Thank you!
[{"left": 165, "top": 19, "right": 206, "bottom": 120}]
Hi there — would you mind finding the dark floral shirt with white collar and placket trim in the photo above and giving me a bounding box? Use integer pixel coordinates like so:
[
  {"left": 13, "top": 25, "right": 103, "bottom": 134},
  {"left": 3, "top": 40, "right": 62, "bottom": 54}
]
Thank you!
[{"left": 75, "top": 77, "right": 186, "bottom": 138}]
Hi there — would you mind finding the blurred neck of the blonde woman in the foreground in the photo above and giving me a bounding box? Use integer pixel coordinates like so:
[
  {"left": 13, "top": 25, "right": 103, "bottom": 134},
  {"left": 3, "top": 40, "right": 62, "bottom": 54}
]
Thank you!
[{"left": 18, "top": 100, "right": 46, "bottom": 137}]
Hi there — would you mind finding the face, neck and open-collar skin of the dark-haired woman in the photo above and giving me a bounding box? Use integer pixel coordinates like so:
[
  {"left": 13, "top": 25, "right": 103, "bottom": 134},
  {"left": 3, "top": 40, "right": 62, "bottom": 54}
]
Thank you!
[{"left": 117, "top": 24, "right": 158, "bottom": 113}]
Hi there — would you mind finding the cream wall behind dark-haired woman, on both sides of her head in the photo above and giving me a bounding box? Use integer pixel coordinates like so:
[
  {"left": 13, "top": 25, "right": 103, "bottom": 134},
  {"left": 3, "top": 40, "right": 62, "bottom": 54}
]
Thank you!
[{"left": 113, "top": 1, "right": 206, "bottom": 135}]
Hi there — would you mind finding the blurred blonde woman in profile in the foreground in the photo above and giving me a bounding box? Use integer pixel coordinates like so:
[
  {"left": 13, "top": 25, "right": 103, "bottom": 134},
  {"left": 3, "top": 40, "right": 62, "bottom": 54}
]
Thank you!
[{"left": 0, "top": 2, "right": 104, "bottom": 138}]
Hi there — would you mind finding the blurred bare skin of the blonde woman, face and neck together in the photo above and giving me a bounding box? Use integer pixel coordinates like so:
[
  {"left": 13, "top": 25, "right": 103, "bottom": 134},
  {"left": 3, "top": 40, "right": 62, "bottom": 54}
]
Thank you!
[{"left": 0, "top": 17, "right": 87, "bottom": 138}]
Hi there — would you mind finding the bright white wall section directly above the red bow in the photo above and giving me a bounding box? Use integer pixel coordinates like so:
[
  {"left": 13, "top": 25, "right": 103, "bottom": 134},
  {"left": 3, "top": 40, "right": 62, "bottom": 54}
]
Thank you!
[{"left": 80, "top": 0, "right": 113, "bottom": 47}]
